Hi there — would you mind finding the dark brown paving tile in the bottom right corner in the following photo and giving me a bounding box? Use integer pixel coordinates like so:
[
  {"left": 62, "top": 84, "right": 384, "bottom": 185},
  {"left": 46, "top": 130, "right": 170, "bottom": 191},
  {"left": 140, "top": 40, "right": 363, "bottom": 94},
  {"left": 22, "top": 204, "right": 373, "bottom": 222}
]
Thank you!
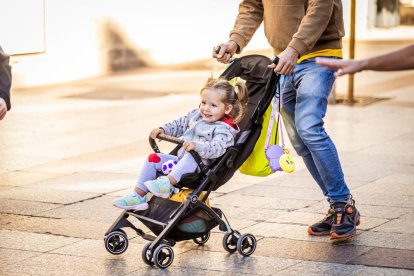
[{"left": 349, "top": 248, "right": 414, "bottom": 274}]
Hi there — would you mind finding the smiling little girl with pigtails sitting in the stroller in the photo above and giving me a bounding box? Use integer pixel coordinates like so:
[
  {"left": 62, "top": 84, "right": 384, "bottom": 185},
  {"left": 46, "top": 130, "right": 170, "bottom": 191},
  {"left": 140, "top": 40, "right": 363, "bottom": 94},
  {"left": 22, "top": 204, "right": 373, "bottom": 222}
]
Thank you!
[{"left": 113, "top": 79, "right": 248, "bottom": 210}]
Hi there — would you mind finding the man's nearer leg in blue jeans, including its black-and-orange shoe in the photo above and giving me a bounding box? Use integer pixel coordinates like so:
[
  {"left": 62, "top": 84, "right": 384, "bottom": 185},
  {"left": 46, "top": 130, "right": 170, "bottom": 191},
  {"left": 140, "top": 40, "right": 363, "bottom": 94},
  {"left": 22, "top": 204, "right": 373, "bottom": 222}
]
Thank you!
[{"left": 294, "top": 60, "right": 359, "bottom": 239}]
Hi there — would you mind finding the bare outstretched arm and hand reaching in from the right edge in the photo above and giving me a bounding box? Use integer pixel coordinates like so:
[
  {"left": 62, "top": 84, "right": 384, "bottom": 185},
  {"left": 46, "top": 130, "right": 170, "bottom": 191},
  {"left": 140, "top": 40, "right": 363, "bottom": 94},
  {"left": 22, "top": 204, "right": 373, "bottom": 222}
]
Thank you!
[{"left": 316, "top": 44, "right": 414, "bottom": 77}]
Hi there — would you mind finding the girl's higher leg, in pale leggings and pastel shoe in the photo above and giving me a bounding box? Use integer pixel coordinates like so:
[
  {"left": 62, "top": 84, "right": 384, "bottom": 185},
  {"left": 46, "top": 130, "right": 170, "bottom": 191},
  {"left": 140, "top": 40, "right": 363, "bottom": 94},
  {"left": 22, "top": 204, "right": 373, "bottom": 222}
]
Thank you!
[{"left": 144, "top": 152, "right": 198, "bottom": 198}]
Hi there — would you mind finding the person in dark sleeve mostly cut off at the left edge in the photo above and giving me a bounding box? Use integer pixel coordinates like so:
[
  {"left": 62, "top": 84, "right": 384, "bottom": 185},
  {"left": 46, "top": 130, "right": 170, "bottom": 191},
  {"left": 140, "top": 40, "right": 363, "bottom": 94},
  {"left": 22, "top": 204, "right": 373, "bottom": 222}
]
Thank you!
[{"left": 0, "top": 47, "right": 11, "bottom": 120}]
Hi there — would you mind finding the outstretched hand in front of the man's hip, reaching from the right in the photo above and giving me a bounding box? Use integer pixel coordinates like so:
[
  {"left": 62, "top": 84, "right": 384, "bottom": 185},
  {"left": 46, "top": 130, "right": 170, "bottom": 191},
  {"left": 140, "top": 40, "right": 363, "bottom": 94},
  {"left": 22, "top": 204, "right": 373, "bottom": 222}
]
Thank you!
[{"left": 316, "top": 58, "right": 365, "bottom": 77}]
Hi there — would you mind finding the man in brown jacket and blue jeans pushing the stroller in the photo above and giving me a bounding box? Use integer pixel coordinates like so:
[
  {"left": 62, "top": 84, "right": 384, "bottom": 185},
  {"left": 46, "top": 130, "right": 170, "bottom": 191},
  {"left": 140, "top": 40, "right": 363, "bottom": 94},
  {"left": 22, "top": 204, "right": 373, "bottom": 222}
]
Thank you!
[{"left": 213, "top": 0, "right": 360, "bottom": 239}]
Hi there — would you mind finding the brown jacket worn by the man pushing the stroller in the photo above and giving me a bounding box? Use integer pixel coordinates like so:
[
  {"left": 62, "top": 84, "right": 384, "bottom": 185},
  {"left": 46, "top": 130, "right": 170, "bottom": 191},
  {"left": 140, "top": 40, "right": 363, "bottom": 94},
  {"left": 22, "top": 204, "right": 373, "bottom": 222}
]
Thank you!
[{"left": 230, "top": 0, "right": 345, "bottom": 56}]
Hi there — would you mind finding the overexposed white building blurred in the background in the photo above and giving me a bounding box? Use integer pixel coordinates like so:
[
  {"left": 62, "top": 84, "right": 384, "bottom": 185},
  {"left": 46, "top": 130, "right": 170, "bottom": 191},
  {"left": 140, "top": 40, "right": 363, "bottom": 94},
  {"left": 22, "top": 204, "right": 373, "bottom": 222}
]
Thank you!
[{"left": 0, "top": 0, "right": 414, "bottom": 87}]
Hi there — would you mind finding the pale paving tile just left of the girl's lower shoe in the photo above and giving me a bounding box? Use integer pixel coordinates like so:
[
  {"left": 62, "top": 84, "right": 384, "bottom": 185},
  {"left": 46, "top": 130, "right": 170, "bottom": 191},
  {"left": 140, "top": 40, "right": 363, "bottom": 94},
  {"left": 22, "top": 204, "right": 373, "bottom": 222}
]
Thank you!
[{"left": 40, "top": 196, "right": 121, "bottom": 222}]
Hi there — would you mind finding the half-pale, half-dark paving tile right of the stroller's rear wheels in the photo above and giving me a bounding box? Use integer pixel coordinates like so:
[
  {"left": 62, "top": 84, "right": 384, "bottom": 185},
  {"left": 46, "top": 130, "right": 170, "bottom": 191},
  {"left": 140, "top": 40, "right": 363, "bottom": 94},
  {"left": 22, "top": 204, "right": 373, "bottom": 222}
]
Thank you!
[{"left": 255, "top": 238, "right": 372, "bottom": 264}]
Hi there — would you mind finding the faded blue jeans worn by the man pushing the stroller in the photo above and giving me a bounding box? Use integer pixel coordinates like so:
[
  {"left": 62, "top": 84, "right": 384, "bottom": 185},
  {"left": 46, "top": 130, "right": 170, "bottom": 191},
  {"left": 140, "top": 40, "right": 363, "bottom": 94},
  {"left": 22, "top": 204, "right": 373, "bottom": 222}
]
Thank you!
[{"left": 280, "top": 59, "right": 350, "bottom": 204}]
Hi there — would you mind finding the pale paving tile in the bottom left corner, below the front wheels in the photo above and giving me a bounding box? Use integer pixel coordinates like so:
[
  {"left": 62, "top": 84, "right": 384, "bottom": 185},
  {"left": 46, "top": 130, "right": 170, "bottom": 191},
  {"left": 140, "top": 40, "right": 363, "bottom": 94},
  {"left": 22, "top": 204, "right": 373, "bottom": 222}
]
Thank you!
[{"left": 0, "top": 254, "right": 146, "bottom": 275}]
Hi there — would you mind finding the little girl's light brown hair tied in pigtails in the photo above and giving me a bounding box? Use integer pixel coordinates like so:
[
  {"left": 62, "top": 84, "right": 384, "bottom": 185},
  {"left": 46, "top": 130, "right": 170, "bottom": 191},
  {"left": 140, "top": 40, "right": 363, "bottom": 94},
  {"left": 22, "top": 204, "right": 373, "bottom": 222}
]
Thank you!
[{"left": 200, "top": 78, "right": 249, "bottom": 124}]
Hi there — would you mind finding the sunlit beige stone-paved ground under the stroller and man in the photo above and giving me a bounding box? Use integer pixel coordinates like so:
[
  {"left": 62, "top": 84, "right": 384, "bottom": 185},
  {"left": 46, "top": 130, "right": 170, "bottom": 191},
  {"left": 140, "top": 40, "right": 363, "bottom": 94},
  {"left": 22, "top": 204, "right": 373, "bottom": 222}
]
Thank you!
[{"left": 0, "top": 42, "right": 414, "bottom": 275}]
